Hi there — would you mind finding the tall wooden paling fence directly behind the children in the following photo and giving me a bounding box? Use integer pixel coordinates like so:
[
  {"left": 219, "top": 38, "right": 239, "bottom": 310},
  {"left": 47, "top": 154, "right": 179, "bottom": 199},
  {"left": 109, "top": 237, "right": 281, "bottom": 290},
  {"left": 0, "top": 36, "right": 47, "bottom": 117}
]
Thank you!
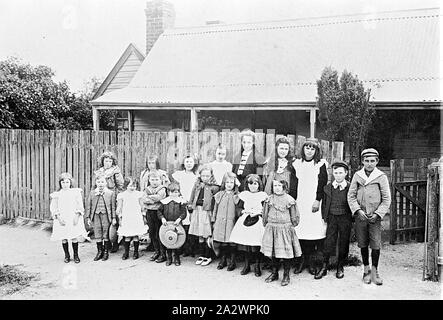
[{"left": 0, "top": 129, "right": 343, "bottom": 220}]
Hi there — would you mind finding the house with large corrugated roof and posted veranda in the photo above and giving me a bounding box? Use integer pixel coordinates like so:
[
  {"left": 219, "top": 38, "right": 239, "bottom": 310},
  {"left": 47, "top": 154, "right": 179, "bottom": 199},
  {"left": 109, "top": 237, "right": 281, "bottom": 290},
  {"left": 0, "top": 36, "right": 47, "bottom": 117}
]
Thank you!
[{"left": 91, "top": 3, "right": 442, "bottom": 157}]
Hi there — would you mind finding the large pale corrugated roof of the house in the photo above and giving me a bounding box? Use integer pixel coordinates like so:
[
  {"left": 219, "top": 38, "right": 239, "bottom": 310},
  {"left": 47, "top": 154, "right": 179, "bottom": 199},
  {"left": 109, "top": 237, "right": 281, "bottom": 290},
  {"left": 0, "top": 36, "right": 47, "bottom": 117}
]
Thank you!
[{"left": 92, "top": 8, "right": 441, "bottom": 106}]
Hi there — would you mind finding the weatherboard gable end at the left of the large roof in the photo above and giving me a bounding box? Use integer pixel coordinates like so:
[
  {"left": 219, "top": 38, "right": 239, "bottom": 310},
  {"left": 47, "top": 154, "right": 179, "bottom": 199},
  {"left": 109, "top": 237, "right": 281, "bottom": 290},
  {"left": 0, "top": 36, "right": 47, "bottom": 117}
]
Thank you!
[{"left": 92, "top": 43, "right": 145, "bottom": 100}]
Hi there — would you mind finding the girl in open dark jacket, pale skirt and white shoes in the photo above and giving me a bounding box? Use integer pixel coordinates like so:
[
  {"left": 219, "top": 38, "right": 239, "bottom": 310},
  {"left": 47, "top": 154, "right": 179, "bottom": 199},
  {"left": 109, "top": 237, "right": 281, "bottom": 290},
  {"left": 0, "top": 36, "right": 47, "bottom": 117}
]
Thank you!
[{"left": 188, "top": 165, "right": 219, "bottom": 266}]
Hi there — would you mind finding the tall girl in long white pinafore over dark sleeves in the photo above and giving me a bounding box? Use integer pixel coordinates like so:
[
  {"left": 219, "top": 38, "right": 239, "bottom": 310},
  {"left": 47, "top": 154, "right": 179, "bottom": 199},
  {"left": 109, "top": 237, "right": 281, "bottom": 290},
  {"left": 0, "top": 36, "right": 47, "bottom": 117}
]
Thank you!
[{"left": 293, "top": 138, "right": 328, "bottom": 275}]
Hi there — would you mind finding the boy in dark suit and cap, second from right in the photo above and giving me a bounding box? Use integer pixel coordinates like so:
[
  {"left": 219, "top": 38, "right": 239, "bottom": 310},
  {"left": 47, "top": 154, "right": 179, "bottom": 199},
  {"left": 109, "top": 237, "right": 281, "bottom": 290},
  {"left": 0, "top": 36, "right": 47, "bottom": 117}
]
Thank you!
[{"left": 314, "top": 161, "right": 352, "bottom": 279}]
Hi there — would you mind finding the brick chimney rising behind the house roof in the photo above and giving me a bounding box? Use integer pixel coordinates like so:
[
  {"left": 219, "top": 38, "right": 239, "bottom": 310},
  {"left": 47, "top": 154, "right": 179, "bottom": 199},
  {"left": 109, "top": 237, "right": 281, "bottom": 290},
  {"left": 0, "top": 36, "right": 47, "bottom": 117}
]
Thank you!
[{"left": 145, "top": 0, "right": 175, "bottom": 55}]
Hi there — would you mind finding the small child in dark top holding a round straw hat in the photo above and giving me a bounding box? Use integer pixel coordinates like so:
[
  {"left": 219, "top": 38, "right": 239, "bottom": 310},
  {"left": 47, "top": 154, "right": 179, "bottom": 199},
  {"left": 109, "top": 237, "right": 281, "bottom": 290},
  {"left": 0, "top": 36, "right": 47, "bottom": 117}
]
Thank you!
[{"left": 158, "top": 182, "right": 186, "bottom": 266}]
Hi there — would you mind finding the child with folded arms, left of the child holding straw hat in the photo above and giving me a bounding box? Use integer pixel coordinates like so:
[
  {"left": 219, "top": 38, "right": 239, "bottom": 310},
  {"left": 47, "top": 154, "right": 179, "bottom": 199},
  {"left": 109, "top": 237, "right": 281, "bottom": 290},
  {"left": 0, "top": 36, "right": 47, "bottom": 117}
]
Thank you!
[{"left": 144, "top": 171, "right": 166, "bottom": 263}]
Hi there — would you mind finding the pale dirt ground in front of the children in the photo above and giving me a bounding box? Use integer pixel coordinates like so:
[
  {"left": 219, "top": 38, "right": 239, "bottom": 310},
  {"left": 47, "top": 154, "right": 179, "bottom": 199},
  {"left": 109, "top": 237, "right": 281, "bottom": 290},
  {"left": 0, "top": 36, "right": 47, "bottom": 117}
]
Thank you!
[{"left": 0, "top": 224, "right": 442, "bottom": 300}]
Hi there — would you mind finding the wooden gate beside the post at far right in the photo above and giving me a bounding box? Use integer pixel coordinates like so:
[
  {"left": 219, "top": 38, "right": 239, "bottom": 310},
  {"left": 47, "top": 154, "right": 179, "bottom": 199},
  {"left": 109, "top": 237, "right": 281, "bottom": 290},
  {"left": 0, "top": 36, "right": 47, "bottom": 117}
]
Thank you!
[{"left": 390, "top": 158, "right": 437, "bottom": 244}]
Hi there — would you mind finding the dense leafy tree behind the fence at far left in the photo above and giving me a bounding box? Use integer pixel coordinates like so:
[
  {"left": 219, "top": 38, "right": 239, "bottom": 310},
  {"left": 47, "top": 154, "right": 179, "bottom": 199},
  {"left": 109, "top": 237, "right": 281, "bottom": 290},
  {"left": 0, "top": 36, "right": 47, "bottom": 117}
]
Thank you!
[{"left": 0, "top": 57, "right": 114, "bottom": 130}]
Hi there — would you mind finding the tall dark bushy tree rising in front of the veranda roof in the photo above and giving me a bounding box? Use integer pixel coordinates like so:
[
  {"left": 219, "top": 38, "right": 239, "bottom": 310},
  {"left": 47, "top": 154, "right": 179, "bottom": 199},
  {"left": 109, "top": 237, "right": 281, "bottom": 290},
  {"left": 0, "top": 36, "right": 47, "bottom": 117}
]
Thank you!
[{"left": 317, "top": 67, "right": 374, "bottom": 172}]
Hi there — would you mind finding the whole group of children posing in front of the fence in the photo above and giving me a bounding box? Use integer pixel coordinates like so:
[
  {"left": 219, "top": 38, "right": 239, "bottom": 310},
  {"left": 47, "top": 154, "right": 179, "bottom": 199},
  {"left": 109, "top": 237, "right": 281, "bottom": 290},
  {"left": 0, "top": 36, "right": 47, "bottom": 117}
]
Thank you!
[{"left": 50, "top": 131, "right": 390, "bottom": 286}]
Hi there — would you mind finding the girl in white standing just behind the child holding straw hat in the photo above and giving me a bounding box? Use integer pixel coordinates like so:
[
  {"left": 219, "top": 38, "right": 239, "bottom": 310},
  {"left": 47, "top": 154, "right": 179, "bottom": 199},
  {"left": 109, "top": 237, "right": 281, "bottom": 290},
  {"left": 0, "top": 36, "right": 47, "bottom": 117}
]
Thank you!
[{"left": 172, "top": 155, "right": 198, "bottom": 257}]
